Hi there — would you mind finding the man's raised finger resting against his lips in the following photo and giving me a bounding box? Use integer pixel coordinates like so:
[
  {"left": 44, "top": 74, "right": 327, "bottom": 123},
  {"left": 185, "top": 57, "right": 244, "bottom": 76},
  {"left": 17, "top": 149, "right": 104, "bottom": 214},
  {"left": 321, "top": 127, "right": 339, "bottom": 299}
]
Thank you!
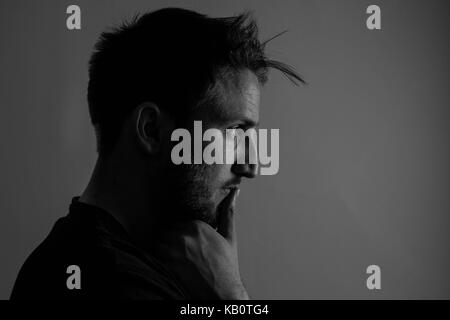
[{"left": 217, "top": 188, "right": 239, "bottom": 243}]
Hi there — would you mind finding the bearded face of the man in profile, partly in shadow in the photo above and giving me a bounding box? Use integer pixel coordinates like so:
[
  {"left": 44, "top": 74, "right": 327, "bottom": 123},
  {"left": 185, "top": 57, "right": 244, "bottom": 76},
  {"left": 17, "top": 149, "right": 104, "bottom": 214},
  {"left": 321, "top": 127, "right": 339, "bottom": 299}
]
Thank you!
[{"left": 169, "top": 71, "right": 260, "bottom": 228}]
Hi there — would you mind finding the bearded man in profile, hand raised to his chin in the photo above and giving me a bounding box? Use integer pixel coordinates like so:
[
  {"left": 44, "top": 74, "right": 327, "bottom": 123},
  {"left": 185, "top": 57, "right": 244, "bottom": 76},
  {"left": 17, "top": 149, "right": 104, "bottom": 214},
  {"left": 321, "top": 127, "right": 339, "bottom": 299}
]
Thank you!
[{"left": 11, "top": 8, "right": 303, "bottom": 299}]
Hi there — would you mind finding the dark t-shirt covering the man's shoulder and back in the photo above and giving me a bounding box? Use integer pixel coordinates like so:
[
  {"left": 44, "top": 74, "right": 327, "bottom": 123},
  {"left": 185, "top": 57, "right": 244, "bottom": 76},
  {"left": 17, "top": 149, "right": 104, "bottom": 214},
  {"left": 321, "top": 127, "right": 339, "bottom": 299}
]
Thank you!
[{"left": 11, "top": 197, "right": 189, "bottom": 300}]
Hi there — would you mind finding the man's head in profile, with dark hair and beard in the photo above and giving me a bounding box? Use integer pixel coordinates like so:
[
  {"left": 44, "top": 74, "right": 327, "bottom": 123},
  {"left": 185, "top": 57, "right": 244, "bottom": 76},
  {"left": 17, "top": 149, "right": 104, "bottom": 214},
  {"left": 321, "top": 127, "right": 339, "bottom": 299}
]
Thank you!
[{"left": 88, "top": 9, "right": 303, "bottom": 226}]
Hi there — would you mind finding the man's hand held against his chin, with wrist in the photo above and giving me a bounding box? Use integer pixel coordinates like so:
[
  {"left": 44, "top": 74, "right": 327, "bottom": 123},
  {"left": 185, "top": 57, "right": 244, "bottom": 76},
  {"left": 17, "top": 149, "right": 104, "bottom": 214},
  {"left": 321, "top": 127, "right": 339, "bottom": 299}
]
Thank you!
[{"left": 153, "top": 189, "right": 249, "bottom": 300}]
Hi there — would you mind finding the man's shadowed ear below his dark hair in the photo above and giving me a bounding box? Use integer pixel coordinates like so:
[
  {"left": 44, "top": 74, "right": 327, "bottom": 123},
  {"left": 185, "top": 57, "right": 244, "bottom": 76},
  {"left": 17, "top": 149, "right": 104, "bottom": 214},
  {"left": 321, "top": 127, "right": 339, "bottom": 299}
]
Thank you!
[{"left": 136, "top": 102, "right": 162, "bottom": 154}]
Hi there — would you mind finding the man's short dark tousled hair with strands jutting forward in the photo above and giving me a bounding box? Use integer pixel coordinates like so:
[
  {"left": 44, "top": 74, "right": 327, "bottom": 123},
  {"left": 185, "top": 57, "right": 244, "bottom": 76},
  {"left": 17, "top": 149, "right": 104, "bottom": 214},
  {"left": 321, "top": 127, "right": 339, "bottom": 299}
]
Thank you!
[{"left": 88, "top": 8, "right": 304, "bottom": 154}]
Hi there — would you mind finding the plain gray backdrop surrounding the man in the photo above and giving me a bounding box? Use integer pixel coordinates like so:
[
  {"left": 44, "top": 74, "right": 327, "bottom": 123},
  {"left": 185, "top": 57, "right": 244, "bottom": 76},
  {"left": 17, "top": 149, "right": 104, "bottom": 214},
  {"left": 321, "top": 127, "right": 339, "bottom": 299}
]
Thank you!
[{"left": 0, "top": 0, "right": 450, "bottom": 299}]
